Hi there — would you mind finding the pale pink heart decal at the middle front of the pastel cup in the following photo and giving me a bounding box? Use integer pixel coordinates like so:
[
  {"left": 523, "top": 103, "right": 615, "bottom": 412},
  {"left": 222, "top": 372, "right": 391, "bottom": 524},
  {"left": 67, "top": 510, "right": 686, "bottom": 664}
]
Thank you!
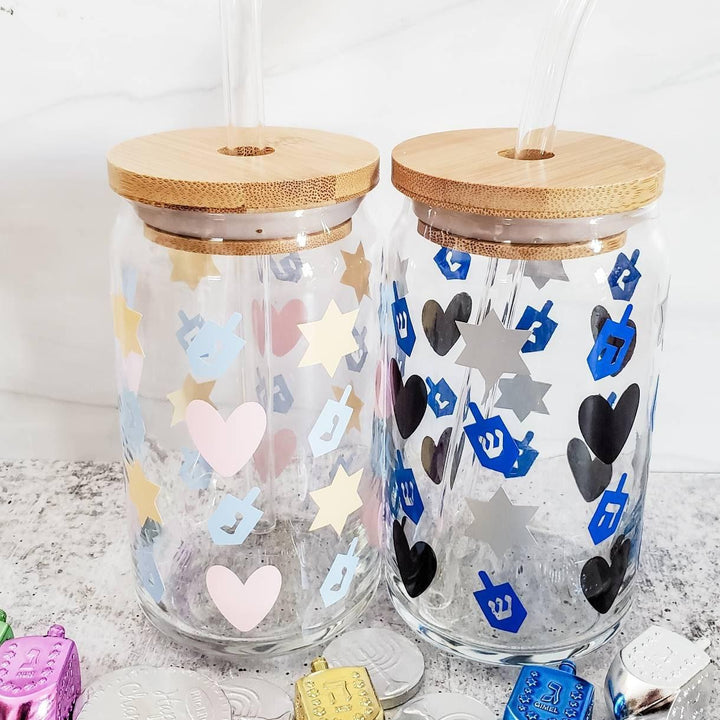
[{"left": 185, "top": 400, "right": 267, "bottom": 477}]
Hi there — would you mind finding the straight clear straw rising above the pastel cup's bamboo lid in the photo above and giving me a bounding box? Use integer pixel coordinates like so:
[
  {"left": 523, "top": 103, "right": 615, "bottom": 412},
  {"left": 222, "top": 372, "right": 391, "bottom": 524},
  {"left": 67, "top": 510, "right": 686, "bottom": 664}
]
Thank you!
[{"left": 220, "top": 0, "right": 265, "bottom": 155}]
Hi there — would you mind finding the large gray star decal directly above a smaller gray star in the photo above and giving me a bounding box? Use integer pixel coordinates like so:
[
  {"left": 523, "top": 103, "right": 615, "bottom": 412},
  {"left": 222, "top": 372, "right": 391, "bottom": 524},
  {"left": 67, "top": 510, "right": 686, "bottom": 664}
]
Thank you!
[{"left": 455, "top": 310, "right": 532, "bottom": 395}]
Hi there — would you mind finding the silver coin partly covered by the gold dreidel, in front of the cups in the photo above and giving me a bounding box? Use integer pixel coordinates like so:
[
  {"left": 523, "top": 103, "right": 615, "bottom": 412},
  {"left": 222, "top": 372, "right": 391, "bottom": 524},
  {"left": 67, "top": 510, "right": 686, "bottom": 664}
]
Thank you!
[{"left": 324, "top": 628, "right": 425, "bottom": 710}]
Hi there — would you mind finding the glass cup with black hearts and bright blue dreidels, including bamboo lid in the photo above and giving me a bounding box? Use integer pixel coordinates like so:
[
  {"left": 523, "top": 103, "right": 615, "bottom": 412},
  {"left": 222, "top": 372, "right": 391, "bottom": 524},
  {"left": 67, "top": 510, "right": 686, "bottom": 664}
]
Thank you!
[{"left": 377, "top": 129, "right": 669, "bottom": 663}]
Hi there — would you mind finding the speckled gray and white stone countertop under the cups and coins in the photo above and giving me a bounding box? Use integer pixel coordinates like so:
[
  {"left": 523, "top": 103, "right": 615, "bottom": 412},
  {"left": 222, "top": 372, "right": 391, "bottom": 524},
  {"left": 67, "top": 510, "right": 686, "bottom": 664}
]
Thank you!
[{"left": 0, "top": 461, "right": 720, "bottom": 720}]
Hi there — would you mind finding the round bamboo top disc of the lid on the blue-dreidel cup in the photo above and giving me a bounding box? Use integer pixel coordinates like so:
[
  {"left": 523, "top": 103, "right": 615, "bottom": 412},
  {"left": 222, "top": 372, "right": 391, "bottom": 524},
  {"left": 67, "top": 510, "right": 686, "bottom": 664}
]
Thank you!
[{"left": 392, "top": 128, "right": 665, "bottom": 218}]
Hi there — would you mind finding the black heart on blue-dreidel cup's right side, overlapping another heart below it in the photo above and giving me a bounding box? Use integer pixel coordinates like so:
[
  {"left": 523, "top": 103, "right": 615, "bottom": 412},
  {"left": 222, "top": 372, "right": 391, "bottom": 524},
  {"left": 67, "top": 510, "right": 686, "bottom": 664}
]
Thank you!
[{"left": 578, "top": 383, "right": 640, "bottom": 465}]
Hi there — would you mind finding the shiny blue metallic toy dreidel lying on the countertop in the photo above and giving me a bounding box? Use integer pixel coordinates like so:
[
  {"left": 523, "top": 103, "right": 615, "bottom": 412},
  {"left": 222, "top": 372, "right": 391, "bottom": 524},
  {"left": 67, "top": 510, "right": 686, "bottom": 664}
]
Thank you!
[{"left": 503, "top": 660, "right": 595, "bottom": 720}]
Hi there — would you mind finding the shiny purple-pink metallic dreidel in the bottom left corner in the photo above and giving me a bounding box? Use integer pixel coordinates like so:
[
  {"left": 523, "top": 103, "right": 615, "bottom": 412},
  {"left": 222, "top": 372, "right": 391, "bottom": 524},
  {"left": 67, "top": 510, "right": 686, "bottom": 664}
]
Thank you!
[{"left": 0, "top": 625, "right": 82, "bottom": 720}]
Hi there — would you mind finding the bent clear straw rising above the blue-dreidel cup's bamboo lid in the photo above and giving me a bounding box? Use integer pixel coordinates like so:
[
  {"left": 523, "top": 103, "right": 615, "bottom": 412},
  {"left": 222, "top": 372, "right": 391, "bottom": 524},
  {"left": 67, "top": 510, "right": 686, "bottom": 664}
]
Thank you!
[{"left": 515, "top": 0, "right": 595, "bottom": 160}]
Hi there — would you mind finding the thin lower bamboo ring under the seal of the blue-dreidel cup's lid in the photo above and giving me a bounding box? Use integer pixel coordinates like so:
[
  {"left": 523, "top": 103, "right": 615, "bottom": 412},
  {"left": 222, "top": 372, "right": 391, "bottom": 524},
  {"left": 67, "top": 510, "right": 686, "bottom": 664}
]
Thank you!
[{"left": 418, "top": 220, "right": 627, "bottom": 260}]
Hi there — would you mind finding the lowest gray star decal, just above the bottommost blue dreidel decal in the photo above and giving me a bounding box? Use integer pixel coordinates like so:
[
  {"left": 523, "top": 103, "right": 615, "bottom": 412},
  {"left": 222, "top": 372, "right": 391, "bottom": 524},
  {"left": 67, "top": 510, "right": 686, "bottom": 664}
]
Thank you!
[{"left": 465, "top": 488, "right": 539, "bottom": 557}]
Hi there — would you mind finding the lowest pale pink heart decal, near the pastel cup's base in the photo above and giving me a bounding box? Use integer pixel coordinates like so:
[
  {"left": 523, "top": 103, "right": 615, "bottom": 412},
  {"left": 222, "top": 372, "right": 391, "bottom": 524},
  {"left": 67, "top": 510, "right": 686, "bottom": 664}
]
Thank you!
[{"left": 205, "top": 565, "right": 282, "bottom": 632}]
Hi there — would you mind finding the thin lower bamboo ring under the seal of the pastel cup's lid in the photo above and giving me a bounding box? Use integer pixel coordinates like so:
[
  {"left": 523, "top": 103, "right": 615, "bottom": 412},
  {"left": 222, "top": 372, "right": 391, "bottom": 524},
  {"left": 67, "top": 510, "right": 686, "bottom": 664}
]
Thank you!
[{"left": 145, "top": 219, "right": 352, "bottom": 255}]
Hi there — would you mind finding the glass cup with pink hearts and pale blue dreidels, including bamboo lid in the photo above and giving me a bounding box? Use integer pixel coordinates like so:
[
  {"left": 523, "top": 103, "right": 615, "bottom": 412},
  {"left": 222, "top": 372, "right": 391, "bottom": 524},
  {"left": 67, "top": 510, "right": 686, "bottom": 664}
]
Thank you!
[{"left": 108, "top": 127, "right": 382, "bottom": 655}]
